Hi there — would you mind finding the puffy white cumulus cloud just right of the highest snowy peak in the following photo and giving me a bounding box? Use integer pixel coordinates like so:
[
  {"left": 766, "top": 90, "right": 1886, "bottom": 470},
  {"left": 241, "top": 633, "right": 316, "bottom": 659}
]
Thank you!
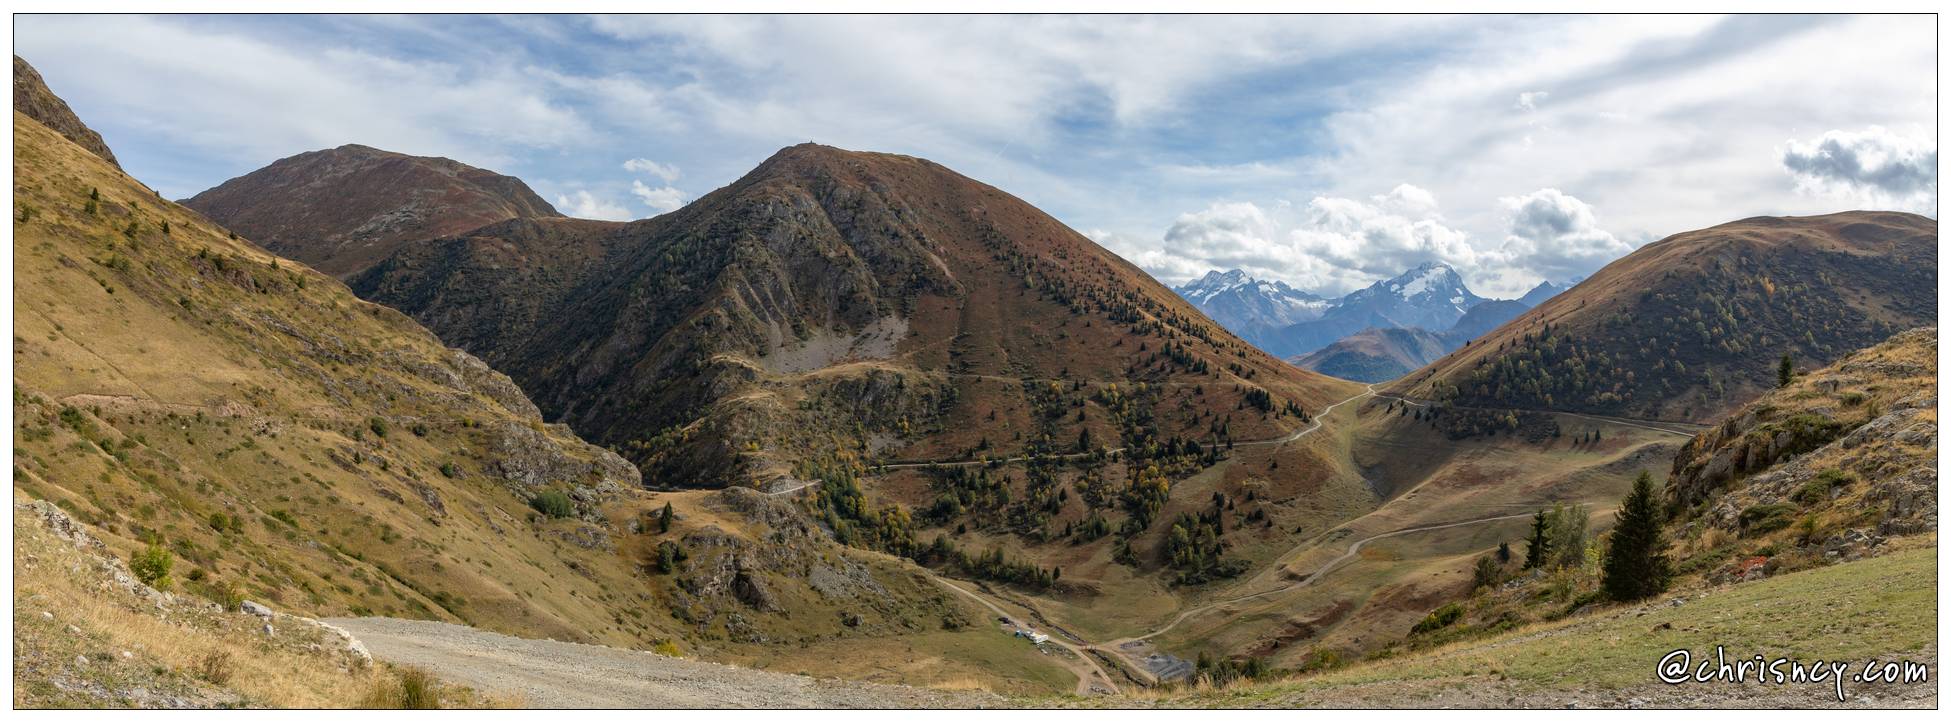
[{"left": 1496, "top": 189, "right": 1633, "bottom": 281}]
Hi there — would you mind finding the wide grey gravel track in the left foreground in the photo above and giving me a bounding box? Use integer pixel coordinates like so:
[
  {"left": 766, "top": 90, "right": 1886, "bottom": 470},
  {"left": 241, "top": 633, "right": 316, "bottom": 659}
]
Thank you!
[{"left": 330, "top": 618, "right": 1005, "bottom": 707}]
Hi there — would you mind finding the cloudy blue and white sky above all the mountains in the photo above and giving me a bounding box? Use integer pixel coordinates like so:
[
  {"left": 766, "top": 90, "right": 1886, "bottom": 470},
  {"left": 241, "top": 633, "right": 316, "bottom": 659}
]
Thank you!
[{"left": 14, "top": 16, "right": 1937, "bottom": 298}]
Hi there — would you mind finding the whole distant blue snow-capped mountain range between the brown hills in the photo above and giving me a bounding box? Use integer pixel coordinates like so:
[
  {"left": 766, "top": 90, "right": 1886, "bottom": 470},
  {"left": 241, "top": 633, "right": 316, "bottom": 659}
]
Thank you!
[{"left": 1175, "top": 263, "right": 1571, "bottom": 382}]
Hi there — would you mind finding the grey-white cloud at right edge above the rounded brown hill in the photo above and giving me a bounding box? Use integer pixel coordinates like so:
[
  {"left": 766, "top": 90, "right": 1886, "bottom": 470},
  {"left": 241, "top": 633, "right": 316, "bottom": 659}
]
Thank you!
[{"left": 1781, "top": 125, "right": 1937, "bottom": 214}]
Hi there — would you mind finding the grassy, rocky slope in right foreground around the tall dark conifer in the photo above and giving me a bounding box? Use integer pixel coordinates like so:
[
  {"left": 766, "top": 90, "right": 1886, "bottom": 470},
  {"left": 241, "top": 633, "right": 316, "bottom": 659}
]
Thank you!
[{"left": 1100, "top": 327, "right": 1937, "bottom": 707}]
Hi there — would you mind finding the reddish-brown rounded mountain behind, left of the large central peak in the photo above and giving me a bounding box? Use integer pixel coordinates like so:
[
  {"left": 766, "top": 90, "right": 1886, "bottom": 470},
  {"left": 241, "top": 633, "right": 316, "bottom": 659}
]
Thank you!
[{"left": 183, "top": 144, "right": 560, "bottom": 279}]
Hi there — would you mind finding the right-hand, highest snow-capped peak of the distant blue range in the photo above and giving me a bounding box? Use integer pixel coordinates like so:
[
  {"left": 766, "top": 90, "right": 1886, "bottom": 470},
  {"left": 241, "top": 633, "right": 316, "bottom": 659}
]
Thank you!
[{"left": 1262, "top": 263, "right": 1485, "bottom": 357}]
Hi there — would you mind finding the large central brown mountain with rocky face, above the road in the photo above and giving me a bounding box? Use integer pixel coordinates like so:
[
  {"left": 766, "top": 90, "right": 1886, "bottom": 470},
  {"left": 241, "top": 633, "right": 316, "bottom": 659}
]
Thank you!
[{"left": 351, "top": 144, "right": 1342, "bottom": 485}]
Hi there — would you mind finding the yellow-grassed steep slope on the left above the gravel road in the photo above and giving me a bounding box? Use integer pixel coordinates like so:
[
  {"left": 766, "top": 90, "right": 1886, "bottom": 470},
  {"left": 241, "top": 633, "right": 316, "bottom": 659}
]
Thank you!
[{"left": 14, "top": 113, "right": 1063, "bottom": 690}]
